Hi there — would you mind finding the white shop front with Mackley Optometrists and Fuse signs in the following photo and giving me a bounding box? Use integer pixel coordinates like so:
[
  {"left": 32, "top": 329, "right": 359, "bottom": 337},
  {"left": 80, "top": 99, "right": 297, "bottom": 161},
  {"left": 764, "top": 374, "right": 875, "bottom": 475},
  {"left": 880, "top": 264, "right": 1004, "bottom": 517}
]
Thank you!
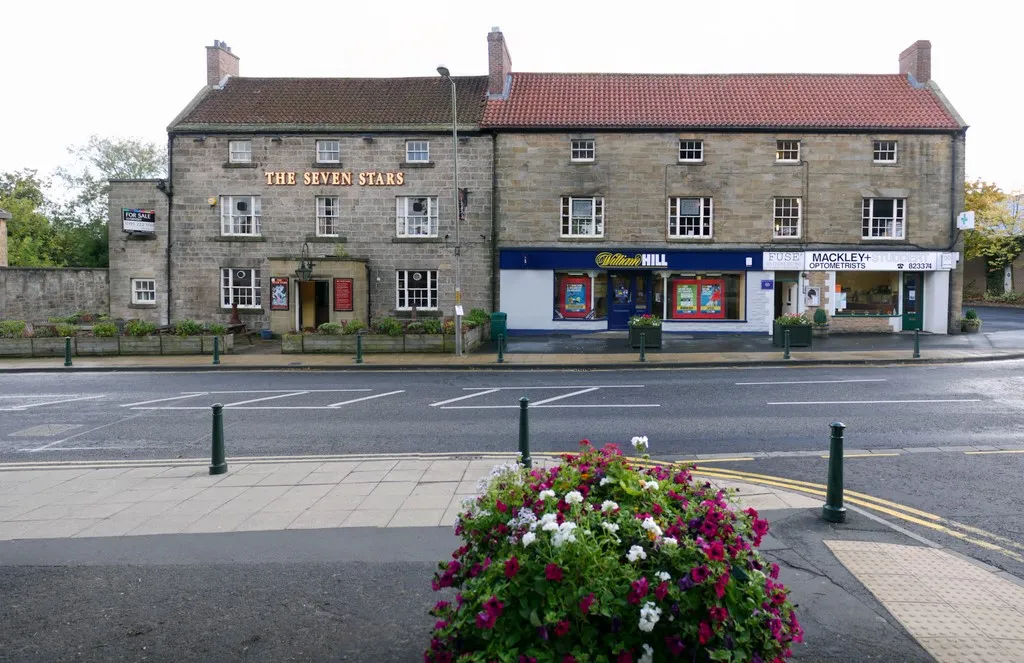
[{"left": 763, "top": 248, "right": 959, "bottom": 334}]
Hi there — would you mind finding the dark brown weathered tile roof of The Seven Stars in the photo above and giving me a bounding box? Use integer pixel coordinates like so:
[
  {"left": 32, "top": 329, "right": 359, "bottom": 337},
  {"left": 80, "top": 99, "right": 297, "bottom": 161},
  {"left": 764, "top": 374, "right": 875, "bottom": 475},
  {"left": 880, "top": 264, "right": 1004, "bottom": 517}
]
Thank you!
[{"left": 172, "top": 76, "right": 487, "bottom": 128}]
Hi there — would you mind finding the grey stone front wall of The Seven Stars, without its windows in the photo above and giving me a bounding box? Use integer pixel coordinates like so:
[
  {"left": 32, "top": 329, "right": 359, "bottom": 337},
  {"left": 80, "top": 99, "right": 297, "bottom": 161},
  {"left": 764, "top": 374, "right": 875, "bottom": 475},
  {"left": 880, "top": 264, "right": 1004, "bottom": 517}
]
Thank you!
[{"left": 163, "top": 133, "right": 493, "bottom": 328}]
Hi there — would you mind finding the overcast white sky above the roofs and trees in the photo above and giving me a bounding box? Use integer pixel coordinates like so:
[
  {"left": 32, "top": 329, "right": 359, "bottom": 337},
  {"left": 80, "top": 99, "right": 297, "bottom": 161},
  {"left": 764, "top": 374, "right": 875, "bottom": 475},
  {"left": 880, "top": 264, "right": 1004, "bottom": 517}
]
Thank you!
[{"left": 0, "top": 0, "right": 1024, "bottom": 191}]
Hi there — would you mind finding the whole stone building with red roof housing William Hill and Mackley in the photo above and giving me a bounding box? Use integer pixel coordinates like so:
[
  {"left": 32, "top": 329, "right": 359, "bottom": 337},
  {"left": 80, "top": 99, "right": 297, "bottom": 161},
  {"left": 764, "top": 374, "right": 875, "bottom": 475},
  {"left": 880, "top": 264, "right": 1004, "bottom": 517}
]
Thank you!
[{"left": 481, "top": 31, "right": 967, "bottom": 333}]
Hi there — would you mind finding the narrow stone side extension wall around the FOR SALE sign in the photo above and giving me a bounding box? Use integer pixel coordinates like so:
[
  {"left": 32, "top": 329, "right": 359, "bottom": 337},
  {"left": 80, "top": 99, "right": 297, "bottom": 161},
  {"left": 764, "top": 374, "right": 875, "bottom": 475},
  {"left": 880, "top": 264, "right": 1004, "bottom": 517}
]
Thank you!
[{"left": 108, "top": 179, "right": 168, "bottom": 325}]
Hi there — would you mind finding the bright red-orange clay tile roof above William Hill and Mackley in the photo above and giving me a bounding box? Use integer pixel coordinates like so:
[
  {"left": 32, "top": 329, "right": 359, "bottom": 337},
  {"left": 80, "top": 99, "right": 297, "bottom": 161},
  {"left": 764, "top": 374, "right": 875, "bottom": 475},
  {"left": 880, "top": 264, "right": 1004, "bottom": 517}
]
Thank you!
[{"left": 482, "top": 74, "right": 959, "bottom": 129}]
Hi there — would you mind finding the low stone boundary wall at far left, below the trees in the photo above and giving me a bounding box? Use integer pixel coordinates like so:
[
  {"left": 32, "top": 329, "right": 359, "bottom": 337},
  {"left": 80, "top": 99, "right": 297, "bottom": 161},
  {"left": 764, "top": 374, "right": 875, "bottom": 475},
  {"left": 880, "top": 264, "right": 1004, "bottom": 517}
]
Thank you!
[{"left": 0, "top": 267, "right": 110, "bottom": 322}]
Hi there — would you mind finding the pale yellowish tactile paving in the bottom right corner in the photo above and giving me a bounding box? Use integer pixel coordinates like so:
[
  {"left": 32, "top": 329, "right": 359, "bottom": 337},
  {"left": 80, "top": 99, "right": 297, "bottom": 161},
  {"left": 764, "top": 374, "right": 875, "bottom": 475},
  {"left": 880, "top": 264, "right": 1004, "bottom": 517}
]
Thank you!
[{"left": 825, "top": 541, "right": 1024, "bottom": 663}]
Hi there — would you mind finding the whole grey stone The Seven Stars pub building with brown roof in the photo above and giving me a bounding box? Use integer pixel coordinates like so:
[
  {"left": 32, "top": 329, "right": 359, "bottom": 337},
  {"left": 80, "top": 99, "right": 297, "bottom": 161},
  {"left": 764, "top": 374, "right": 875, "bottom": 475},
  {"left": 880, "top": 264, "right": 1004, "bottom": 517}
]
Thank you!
[{"left": 110, "top": 41, "right": 494, "bottom": 333}]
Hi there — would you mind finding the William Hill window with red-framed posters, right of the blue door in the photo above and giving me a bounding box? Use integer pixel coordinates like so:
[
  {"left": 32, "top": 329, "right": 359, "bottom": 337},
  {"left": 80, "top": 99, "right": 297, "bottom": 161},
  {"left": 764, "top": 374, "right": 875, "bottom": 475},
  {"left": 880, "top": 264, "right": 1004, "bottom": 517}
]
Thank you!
[{"left": 667, "top": 272, "right": 746, "bottom": 322}]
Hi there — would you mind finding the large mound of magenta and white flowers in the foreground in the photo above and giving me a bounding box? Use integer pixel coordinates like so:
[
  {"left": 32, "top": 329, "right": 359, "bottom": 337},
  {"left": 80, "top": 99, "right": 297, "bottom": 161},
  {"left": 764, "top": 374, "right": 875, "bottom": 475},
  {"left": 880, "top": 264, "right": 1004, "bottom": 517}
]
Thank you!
[{"left": 424, "top": 439, "right": 803, "bottom": 663}]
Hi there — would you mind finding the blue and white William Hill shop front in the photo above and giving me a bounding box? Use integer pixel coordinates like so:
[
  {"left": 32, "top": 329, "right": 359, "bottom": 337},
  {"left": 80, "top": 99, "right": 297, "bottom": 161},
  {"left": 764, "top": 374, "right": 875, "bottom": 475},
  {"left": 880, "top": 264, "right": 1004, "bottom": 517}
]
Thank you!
[{"left": 500, "top": 249, "right": 773, "bottom": 334}]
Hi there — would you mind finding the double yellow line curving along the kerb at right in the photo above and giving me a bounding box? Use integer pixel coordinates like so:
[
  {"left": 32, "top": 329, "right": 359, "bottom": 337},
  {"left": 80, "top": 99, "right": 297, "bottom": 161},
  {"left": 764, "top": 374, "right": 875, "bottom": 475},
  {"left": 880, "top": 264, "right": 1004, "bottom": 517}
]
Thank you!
[{"left": 637, "top": 459, "right": 1024, "bottom": 564}]
